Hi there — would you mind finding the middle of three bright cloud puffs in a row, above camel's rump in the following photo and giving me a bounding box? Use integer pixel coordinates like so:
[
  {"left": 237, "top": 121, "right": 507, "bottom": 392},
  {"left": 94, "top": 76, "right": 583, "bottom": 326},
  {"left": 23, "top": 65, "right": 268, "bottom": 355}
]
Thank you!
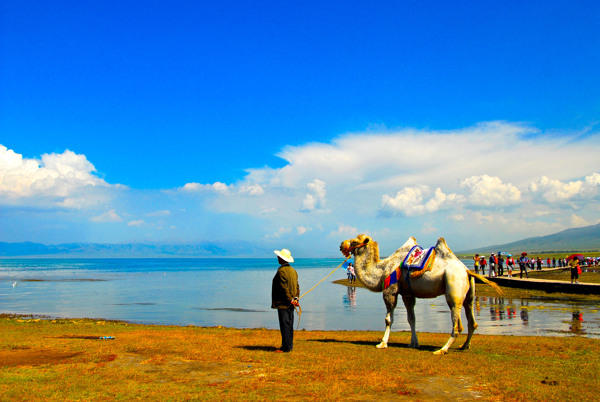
[{"left": 460, "top": 175, "right": 521, "bottom": 207}]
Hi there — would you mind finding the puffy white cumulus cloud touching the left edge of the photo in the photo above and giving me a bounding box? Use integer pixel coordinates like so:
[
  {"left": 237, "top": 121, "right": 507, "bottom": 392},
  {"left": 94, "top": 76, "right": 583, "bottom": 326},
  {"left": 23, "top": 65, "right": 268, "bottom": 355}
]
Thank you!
[{"left": 0, "top": 145, "right": 109, "bottom": 208}]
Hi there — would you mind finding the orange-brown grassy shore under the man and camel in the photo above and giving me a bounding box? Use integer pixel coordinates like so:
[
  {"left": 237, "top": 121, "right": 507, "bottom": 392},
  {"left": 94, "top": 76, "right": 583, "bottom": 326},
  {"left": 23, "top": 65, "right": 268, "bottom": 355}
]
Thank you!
[{"left": 0, "top": 316, "right": 600, "bottom": 400}]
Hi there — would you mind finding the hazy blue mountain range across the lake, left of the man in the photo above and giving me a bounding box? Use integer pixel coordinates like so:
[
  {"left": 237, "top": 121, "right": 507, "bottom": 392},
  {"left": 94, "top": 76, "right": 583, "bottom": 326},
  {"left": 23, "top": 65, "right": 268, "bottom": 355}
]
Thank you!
[{"left": 0, "top": 242, "right": 266, "bottom": 258}]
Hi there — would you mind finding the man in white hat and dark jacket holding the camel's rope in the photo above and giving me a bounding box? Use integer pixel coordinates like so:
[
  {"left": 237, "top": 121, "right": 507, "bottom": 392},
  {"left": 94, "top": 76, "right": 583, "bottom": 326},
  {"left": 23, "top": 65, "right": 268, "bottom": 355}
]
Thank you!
[{"left": 271, "top": 248, "right": 300, "bottom": 353}]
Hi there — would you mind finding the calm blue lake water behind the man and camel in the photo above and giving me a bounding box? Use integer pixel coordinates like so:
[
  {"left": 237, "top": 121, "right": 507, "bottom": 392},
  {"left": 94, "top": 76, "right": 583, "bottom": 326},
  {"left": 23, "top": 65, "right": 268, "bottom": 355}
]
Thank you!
[{"left": 0, "top": 258, "right": 600, "bottom": 338}]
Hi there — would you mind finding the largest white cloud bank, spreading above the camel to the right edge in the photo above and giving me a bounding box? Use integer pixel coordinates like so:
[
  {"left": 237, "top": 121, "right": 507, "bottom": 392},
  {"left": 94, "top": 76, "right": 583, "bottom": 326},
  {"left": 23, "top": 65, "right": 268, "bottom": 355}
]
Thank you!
[{"left": 175, "top": 122, "right": 600, "bottom": 251}]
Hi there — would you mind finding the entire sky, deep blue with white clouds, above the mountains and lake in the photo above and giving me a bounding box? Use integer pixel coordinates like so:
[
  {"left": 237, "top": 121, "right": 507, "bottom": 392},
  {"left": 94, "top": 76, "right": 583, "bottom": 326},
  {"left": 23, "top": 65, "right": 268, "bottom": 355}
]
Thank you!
[{"left": 0, "top": 1, "right": 600, "bottom": 256}]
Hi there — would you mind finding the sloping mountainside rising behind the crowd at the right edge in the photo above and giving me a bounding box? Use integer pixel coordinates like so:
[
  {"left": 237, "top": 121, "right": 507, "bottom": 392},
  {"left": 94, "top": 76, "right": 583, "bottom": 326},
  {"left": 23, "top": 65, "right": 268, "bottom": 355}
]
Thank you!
[{"left": 457, "top": 224, "right": 600, "bottom": 255}]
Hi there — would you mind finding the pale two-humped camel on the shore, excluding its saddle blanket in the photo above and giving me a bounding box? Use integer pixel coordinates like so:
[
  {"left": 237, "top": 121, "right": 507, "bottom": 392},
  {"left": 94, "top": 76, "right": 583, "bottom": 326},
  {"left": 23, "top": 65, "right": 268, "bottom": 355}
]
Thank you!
[{"left": 340, "top": 234, "right": 502, "bottom": 354}]
